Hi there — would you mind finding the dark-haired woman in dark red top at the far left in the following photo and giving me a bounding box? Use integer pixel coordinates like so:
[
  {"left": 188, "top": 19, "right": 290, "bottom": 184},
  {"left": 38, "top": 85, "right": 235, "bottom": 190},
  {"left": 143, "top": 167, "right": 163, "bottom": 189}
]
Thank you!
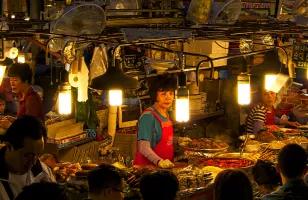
[{"left": 8, "top": 63, "right": 44, "bottom": 121}]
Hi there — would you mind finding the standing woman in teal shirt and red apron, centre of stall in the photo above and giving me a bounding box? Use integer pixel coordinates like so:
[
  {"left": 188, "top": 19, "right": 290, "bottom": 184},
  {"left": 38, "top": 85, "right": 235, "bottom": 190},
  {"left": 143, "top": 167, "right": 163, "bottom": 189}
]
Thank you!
[{"left": 134, "top": 76, "right": 176, "bottom": 168}]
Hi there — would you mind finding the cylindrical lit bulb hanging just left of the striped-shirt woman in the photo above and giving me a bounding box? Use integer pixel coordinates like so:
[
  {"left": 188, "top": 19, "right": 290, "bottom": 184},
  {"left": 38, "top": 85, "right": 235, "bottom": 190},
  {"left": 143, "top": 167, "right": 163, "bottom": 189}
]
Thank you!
[{"left": 237, "top": 74, "right": 251, "bottom": 105}]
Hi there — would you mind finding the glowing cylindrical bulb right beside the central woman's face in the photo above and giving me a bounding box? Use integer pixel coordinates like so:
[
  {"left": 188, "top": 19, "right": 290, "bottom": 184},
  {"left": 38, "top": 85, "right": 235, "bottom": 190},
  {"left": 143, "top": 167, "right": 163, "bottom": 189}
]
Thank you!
[{"left": 175, "top": 96, "right": 189, "bottom": 122}]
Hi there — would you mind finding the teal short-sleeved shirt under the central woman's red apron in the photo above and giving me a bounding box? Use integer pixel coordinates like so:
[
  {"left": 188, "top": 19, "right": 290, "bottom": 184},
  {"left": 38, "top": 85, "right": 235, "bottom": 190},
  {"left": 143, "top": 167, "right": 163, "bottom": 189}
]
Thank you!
[{"left": 138, "top": 108, "right": 168, "bottom": 148}]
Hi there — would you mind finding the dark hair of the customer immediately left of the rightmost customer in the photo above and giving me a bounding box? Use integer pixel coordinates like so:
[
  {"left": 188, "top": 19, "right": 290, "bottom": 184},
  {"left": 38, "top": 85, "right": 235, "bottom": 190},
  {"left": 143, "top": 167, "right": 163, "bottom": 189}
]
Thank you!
[{"left": 252, "top": 160, "right": 281, "bottom": 186}]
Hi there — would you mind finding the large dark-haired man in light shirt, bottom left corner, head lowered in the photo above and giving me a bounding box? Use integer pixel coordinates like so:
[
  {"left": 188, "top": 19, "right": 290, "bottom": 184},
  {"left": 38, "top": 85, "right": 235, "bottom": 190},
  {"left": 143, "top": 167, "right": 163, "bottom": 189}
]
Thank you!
[{"left": 0, "top": 116, "right": 55, "bottom": 200}]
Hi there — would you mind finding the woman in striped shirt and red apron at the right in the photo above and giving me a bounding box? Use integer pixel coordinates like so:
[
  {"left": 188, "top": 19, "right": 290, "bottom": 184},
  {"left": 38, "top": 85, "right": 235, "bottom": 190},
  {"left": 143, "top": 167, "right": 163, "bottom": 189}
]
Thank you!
[{"left": 246, "top": 90, "right": 300, "bottom": 134}]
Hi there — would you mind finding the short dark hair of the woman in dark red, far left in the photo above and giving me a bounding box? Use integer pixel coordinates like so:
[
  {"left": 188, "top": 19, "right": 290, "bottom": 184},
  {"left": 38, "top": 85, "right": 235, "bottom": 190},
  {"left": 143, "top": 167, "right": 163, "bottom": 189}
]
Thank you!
[{"left": 8, "top": 63, "right": 32, "bottom": 83}]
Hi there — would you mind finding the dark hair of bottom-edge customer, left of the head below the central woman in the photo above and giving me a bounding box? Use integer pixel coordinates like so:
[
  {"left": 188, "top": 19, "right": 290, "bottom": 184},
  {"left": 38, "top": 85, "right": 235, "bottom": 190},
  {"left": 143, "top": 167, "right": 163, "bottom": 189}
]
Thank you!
[{"left": 88, "top": 164, "right": 122, "bottom": 194}]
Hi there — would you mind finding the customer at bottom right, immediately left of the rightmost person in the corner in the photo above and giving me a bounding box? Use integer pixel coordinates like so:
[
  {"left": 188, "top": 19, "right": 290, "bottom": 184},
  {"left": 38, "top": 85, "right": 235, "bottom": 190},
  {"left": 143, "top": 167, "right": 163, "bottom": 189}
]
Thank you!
[{"left": 252, "top": 160, "right": 281, "bottom": 196}]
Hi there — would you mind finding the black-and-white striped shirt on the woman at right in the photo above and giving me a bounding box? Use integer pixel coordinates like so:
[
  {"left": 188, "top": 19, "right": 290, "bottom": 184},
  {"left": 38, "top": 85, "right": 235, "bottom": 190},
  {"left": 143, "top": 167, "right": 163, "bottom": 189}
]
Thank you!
[{"left": 246, "top": 104, "right": 267, "bottom": 133}]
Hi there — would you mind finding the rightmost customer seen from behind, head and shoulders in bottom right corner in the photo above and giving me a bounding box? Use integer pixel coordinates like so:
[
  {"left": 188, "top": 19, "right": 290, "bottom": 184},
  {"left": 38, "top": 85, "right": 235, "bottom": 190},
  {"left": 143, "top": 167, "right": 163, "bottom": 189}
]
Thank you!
[{"left": 264, "top": 144, "right": 308, "bottom": 200}]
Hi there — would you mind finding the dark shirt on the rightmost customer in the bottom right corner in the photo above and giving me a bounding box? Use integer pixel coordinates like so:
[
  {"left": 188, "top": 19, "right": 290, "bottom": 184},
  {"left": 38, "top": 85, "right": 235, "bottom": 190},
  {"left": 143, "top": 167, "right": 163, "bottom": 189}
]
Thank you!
[{"left": 263, "top": 179, "right": 308, "bottom": 200}]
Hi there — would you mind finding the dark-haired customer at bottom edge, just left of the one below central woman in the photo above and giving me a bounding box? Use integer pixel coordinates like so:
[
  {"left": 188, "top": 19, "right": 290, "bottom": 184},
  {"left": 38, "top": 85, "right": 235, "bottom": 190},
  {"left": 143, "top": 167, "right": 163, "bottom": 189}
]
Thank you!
[{"left": 88, "top": 164, "right": 124, "bottom": 200}]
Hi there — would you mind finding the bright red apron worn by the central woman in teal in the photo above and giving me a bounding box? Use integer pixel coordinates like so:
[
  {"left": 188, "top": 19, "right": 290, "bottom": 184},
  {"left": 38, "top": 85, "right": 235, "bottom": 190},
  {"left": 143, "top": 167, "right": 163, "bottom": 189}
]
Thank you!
[{"left": 134, "top": 108, "right": 173, "bottom": 165}]
